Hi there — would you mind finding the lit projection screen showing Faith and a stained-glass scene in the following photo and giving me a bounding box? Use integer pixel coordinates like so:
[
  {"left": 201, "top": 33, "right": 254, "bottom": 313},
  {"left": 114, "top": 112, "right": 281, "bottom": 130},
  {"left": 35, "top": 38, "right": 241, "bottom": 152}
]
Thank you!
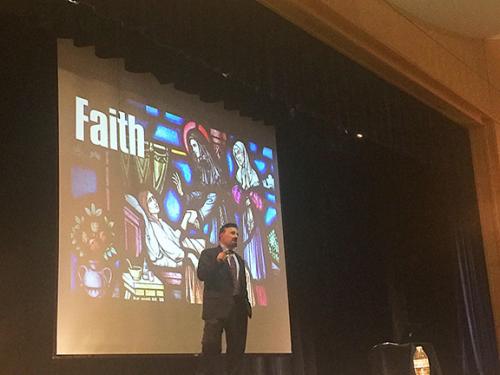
[{"left": 56, "top": 40, "right": 291, "bottom": 355}]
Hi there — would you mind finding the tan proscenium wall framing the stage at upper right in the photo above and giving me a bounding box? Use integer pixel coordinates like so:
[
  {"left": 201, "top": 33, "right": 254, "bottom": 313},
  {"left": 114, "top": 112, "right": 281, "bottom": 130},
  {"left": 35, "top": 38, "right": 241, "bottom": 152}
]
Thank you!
[{"left": 260, "top": 0, "right": 500, "bottom": 354}]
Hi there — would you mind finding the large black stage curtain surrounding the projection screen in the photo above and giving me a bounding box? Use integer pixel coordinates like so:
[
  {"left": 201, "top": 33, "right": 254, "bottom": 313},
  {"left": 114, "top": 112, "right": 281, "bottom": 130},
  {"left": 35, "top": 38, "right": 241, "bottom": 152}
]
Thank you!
[{"left": 0, "top": 0, "right": 498, "bottom": 375}]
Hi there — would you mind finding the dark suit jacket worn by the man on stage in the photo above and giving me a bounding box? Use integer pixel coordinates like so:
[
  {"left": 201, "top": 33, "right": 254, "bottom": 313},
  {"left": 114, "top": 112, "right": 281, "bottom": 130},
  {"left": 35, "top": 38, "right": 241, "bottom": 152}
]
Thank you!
[{"left": 197, "top": 246, "right": 252, "bottom": 320}]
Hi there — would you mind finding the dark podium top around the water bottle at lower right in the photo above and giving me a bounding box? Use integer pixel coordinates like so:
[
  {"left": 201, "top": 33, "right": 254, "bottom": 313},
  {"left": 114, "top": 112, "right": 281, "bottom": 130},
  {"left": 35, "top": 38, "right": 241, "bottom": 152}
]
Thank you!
[{"left": 369, "top": 342, "right": 443, "bottom": 375}]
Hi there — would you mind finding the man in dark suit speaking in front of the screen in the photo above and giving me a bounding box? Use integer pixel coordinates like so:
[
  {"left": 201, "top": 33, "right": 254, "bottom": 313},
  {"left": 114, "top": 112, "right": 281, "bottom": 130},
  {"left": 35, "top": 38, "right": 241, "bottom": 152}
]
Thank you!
[{"left": 198, "top": 223, "right": 252, "bottom": 375}]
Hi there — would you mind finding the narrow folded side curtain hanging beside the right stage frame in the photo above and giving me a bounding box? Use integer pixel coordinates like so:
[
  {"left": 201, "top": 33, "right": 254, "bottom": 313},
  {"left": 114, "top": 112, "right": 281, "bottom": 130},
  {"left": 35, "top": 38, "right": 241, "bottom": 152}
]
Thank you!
[{"left": 453, "top": 141, "right": 500, "bottom": 375}]
